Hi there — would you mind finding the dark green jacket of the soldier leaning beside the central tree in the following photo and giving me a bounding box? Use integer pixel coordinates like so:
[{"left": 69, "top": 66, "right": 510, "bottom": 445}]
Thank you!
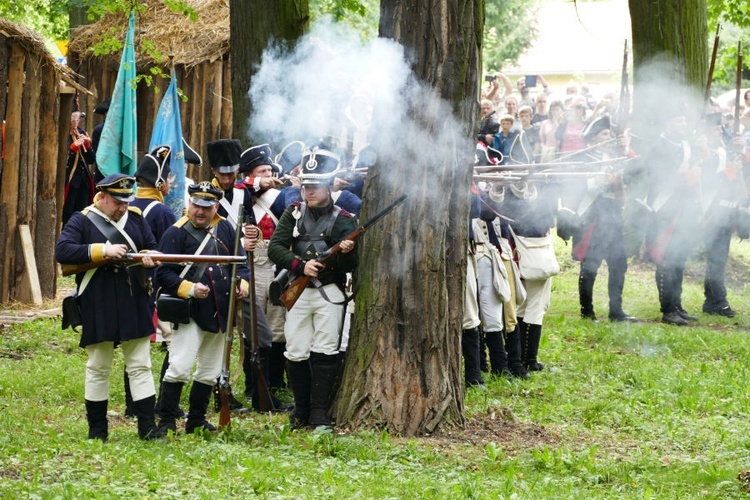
[{"left": 268, "top": 203, "right": 357, "bottom": 287}]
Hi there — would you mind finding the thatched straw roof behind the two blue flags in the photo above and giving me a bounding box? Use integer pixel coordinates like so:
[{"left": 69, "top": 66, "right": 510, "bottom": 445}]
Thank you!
[{"left": 68, "top": 0, "right": 229, "bottom": 68}]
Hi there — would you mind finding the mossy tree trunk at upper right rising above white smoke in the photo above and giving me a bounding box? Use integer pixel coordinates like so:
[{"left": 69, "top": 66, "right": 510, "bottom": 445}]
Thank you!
[{"left": 629, "top": 0, "right": 709, "bottom": 136}]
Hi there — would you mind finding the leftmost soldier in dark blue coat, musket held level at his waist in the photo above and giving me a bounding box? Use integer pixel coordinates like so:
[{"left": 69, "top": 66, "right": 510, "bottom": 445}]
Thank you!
[{"left": 55, "top": 174, "right": 159, "bottom": 441}]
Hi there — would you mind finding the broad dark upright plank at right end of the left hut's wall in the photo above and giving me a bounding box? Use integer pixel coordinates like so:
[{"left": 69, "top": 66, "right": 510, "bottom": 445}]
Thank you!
[{"left": 34, "top": 60, "right": 60, "bottom": 299}]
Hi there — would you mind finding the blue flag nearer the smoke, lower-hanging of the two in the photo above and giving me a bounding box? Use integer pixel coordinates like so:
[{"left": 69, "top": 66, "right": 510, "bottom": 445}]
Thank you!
[{"left": 148, "top": 69, "right": 185, "bottom": 219}]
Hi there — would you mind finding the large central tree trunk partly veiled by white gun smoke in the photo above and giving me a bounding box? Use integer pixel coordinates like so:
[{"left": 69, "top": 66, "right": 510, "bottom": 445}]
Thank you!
[{"left": 336, "top": 0, "right": 484, "bottom": 436}]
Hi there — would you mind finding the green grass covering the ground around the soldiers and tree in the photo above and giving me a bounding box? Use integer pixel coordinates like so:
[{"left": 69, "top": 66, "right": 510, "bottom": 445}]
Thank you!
[{"left": 0, "top": 242, "right": 750, "bottom": 499}]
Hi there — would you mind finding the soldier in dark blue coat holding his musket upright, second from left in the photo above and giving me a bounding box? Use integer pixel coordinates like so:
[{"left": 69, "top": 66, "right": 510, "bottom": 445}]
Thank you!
[{"left": 156, "top": 182, "right": 250, "bottom": 434}]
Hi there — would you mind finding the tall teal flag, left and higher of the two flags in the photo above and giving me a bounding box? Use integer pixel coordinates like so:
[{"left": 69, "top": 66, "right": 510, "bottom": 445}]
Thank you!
[{"left": 96, "top": 12, "right": 138, "bottom": 177}]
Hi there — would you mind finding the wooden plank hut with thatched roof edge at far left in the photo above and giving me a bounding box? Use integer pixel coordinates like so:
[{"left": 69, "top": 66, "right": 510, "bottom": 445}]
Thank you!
[{"left": 0, "top": 20, "right": 85, "bottom": 304}]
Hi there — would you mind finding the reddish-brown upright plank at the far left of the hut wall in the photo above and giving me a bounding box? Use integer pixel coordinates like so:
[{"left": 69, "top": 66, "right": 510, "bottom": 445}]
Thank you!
[{"left": 0, "top": 44, "right": 26, "bottom": 303}]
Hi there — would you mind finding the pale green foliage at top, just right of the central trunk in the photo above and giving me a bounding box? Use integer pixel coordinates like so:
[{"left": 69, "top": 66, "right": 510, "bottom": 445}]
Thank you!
[{"left": 482, "top": 0, "right": 539, "bottom": 73}]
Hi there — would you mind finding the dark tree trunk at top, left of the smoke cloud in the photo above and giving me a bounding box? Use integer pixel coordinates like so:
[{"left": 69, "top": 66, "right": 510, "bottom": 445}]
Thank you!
[{"left": 229, "top": 0, "right": 310, "bottom": 146}]
